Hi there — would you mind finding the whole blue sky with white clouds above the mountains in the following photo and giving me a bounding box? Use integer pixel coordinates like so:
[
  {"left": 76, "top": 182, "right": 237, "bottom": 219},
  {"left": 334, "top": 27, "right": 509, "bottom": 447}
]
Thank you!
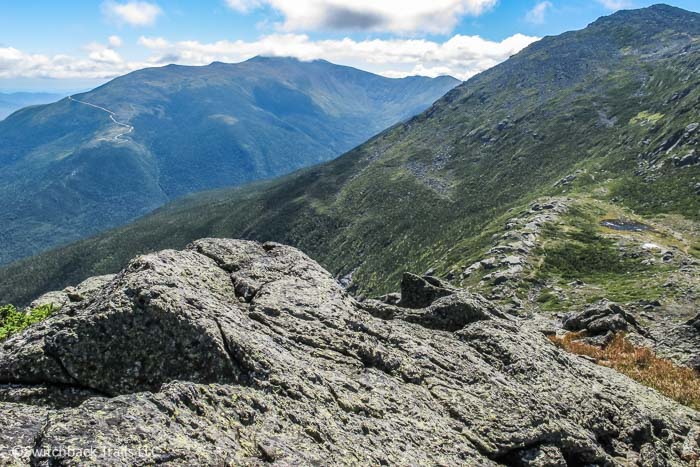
[{"left": 0, "top": 0, "right": 700, "bottom": 92}]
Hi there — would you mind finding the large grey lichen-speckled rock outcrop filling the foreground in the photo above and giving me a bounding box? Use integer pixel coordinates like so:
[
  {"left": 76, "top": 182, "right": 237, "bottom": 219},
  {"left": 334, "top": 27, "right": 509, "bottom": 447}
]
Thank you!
[{"left": 0, "top": 239, "right": 700, "bottom": 466}]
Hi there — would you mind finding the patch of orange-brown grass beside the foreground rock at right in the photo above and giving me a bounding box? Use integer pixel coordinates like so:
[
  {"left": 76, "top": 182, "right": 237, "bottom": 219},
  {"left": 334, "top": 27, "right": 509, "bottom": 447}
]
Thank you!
[{"left": 549, "top": 333, "right": 700, "bottom": 410}]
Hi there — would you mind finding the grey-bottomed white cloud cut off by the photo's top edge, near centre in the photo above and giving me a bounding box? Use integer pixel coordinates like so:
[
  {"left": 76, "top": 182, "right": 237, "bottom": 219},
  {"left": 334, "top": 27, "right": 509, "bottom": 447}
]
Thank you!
[{"left": 226, "top": 0, "right": 498, "bottom": 33}]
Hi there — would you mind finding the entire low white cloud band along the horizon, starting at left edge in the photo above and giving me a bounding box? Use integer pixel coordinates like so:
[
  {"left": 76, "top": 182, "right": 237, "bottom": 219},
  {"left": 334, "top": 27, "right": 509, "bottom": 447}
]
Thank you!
[{"left": 0, "top": 29, "right": 537, "bottom": 79}]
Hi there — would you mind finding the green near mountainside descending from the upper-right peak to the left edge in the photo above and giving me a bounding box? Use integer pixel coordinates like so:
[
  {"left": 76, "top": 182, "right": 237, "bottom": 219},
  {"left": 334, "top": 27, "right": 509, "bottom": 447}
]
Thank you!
[{"left": 0, "top": 7, "right": 700, "bottom": 308}]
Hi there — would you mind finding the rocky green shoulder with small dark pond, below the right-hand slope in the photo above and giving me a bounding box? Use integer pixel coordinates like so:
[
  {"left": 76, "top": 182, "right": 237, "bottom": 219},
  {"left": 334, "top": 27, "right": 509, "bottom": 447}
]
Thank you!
[{"left": 448, "top": 195, "right": 700, "bottom": 370}]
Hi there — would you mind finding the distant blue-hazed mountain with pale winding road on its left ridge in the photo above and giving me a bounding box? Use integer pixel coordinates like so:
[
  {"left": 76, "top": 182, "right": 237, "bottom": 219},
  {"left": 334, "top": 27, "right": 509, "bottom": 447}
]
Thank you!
[{"left": 0, "top": 57, "right": 458, "bottom": 264}]
